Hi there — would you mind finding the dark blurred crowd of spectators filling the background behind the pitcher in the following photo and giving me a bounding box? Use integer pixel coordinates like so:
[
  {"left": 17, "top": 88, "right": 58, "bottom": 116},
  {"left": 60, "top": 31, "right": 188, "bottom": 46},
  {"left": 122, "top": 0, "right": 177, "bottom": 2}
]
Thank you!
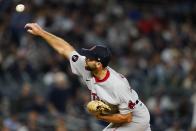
[{"left": 0, "top": 0, "right": 196, "bottom": 131}]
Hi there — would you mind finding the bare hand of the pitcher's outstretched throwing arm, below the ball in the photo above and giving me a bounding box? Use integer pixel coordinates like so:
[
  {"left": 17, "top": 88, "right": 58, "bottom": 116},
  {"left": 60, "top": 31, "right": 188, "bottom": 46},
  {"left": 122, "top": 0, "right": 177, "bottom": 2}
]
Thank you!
[{"left": 25, "top": 23, "right": 44, "bottom": 36}]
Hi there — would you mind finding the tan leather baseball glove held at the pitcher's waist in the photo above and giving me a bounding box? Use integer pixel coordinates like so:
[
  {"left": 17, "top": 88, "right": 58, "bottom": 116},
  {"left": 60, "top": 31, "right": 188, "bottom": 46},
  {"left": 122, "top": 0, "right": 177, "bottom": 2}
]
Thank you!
[{"left": 87, "top": 100, "right": 111, "bottom": 115}]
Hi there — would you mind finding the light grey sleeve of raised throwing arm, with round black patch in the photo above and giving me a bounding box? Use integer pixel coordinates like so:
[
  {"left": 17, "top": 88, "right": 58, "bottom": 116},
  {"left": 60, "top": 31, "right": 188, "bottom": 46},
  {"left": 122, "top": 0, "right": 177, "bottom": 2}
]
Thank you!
[{"left": 69, "top": 51, "right": 89, "bottom": 78}]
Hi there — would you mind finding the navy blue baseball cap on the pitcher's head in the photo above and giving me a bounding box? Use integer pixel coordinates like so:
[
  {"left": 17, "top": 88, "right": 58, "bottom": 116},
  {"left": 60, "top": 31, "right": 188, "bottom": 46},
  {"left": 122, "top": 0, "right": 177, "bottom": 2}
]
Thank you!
[{"left": 81, "top": 45, "right": 111, "bottom": 67}]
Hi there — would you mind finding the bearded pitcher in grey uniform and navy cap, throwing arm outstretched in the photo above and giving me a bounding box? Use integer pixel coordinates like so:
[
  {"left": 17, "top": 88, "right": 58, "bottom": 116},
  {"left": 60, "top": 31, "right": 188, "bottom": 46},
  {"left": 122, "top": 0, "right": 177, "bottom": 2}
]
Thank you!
[{"left": 25, "top": 23, "right": 151, "bottom": 131}]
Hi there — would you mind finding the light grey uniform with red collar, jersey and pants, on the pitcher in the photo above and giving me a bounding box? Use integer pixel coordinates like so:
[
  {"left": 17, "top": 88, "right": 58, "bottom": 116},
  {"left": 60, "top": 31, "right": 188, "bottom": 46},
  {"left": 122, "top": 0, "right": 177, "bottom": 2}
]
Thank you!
[{"left": 69, "top": 51, "right": 150, "bottom": 131}]
